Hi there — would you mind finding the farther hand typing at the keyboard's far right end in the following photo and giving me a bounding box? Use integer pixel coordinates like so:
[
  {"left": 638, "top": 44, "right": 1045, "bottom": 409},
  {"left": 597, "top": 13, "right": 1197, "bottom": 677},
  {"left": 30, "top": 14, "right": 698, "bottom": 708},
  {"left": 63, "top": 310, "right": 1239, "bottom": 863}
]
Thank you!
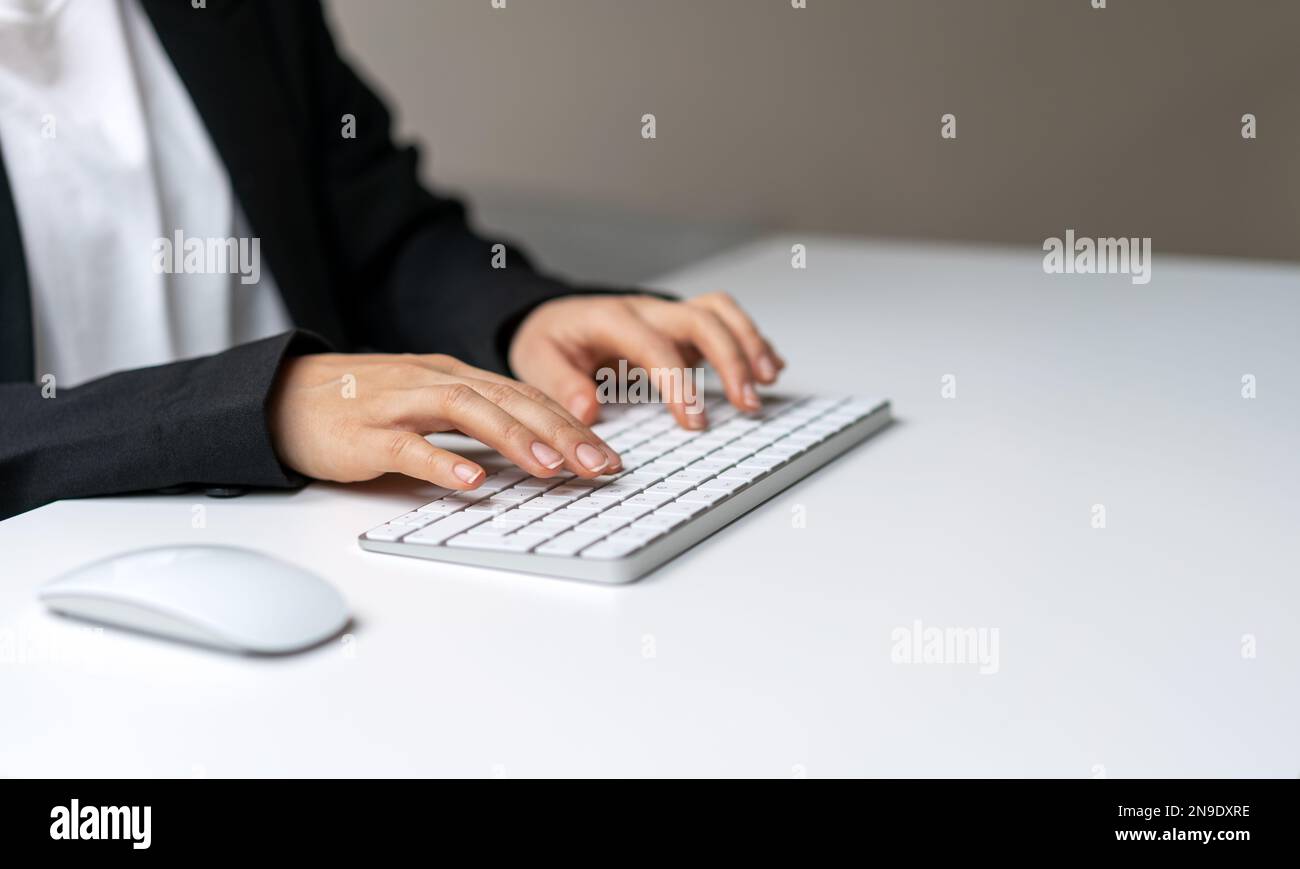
[{"left": 510, "top": 293, "right": 785, "bottom": 428}]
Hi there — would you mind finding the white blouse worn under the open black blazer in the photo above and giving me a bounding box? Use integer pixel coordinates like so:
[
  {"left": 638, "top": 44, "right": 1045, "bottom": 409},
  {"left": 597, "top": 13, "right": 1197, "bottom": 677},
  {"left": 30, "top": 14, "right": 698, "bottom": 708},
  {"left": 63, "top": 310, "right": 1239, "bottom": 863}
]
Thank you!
[{"left": 0, "top": 0, "right": 290, "bottom": 386}]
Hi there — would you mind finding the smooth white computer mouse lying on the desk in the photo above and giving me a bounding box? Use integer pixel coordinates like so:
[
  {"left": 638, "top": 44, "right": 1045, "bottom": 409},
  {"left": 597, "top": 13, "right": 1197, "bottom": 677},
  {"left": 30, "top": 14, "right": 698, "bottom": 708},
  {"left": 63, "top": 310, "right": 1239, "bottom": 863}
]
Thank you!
[{"left": 38, "top": 546, "right": 350, "bottom": 654}]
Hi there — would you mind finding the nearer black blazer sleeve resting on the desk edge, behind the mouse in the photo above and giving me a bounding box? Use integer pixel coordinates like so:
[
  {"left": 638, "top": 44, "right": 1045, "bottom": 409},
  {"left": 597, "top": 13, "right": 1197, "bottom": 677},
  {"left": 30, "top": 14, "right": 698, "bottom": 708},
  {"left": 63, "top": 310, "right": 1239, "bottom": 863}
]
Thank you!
[{"left": 0, "top": 332, "right": 329, "bottom": 519}]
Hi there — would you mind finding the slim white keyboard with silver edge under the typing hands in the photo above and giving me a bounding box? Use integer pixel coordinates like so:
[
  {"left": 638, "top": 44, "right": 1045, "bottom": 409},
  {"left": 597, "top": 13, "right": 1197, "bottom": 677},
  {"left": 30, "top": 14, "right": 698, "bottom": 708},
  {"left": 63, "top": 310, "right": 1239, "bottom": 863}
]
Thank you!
[{"left": 360, "top": 397, "right": 889, "bottom": 583}]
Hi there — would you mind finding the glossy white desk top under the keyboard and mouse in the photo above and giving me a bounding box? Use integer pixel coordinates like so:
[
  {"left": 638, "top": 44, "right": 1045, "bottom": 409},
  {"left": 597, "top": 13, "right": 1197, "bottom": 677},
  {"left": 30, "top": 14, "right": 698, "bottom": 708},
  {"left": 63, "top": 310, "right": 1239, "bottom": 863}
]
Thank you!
[{"left": 0, "top": 238, "right": 1300, "bottom": 777}]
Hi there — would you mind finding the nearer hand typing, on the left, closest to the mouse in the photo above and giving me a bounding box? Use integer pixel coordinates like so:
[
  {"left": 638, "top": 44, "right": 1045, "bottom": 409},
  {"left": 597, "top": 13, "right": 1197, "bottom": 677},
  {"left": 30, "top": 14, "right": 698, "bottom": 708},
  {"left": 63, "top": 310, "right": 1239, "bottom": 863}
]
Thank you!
[{"left": 267, "top": 354, "right": 621, "bottom": 489}]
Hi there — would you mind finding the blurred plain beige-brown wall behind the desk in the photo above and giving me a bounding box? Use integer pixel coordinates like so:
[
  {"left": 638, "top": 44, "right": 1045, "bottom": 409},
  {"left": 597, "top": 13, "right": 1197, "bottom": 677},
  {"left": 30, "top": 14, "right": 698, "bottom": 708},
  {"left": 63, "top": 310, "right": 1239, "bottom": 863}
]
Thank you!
[{"left": 332, "top": 0, "right": 1300, "bottom": 274}]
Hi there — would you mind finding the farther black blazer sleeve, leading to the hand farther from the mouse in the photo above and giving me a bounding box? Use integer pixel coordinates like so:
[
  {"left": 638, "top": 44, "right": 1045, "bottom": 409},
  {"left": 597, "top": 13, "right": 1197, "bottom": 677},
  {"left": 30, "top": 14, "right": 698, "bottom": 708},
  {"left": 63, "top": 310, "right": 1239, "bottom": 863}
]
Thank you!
[{"left": 302, "top": 0, "right": 634, "bottom": 371}]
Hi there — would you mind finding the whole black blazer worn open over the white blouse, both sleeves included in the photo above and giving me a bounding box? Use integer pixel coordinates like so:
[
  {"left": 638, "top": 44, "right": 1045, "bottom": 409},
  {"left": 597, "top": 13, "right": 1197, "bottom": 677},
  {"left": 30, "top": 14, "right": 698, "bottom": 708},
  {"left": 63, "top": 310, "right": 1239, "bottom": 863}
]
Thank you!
[{"left": 0, "top": 0, "right": 608, "bottom": 518}]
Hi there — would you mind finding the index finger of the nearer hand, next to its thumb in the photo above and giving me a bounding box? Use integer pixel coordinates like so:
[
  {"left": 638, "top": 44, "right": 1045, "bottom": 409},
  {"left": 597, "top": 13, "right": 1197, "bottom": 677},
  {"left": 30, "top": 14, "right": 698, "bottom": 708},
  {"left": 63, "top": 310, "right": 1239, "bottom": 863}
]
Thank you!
[{"left": 386, "top": 382, "right": 579, "bottom": 476}]
